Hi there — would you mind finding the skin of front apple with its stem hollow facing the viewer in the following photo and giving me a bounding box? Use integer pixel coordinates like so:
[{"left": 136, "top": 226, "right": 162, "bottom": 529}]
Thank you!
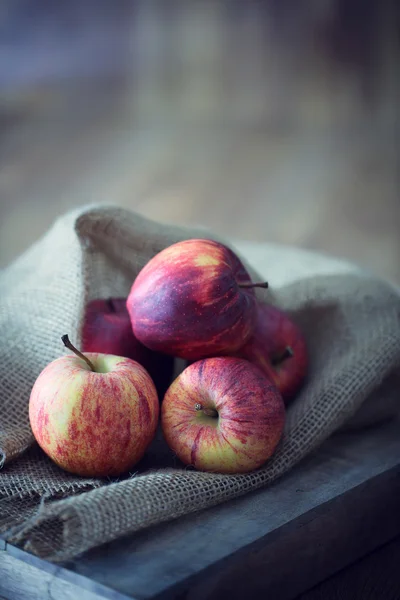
[{"left": 161, "top": 357, "right": 285, "bottom": 473}]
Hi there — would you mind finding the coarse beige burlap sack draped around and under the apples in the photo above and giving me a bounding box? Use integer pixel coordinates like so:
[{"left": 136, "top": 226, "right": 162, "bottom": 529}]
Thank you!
[{"left": 0, "top": 207, "right": 400, "bottom": 560}]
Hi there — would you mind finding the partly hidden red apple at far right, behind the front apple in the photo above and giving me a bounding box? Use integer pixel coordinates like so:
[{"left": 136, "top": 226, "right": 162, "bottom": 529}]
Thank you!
[{"left": 235, "top": 302, "right": 308, "bottom": 403}]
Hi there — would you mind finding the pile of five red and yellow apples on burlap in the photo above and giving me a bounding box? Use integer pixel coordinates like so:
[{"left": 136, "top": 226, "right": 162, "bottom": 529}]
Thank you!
[{"left": 29, "top": 239, "right": 307, "bottom": 477}]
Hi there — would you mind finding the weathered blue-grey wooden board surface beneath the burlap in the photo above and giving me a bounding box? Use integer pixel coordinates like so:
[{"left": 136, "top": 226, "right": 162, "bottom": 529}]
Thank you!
[{"left": 0, "top": 421, "right": 400, "bottom": 600}]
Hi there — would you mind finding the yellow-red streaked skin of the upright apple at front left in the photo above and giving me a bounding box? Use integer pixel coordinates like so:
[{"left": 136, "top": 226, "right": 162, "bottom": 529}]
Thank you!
[{"left": 29, "top": 353, "right": 160, "bottom": 477}]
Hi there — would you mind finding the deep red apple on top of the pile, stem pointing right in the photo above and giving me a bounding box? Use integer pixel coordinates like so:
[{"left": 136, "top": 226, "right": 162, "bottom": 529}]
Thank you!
[{"left": 127, "top": 239, "right": 268, "bottom": 360}]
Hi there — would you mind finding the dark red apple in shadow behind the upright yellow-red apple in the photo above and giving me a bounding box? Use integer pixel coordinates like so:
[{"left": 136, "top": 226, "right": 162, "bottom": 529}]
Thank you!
[{"left": 82, "top": 298, "right": 174, "bottom": 398}]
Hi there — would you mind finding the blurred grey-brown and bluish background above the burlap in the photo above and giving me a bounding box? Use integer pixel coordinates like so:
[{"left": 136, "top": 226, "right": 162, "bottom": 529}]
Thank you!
[{"left": 0, "top": 0, "right": 400, "bottom": 283}]
